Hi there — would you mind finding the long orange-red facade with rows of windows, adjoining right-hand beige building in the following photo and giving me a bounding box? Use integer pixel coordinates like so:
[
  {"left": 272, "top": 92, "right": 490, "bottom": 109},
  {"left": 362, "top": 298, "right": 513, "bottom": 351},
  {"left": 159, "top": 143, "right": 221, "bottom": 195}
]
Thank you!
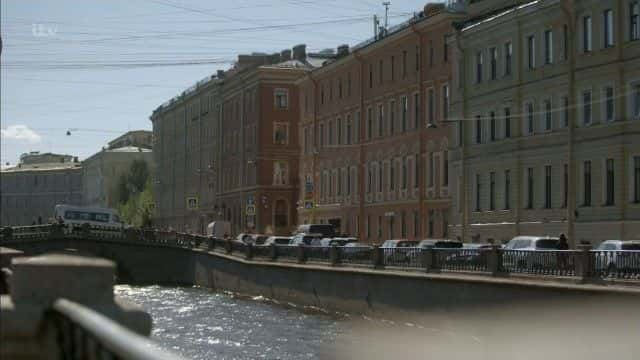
[{"left": 298, "top": 5, "right": 461, "bottom": 242}]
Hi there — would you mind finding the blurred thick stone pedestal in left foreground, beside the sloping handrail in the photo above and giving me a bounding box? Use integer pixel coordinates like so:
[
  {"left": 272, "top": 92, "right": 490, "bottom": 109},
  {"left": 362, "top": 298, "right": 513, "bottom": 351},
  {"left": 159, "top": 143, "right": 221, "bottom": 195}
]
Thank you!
[{"left": 0, "top": 254, "right": 151, "bottom": 359}]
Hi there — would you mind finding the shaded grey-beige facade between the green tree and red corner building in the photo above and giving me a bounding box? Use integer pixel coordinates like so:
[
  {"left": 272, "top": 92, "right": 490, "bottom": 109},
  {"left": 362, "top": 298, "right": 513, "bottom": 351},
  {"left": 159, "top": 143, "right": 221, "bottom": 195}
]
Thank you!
[{"left": 151, "top": 74, "right": 222, "bottom": 233}]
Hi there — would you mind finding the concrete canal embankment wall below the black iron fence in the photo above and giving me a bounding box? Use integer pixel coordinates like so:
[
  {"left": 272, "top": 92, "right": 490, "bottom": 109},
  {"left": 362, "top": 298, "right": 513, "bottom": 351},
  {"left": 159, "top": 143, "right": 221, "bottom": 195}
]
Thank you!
[{"left": 6, "top": 240, "right": 640, "bottom": 314}]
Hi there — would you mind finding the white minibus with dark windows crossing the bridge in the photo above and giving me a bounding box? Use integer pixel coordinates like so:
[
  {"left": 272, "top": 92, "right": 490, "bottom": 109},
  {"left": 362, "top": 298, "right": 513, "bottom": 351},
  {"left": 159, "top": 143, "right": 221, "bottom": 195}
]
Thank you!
[{"left": 54, "top": 205, "right": 124, "bottom": 227}]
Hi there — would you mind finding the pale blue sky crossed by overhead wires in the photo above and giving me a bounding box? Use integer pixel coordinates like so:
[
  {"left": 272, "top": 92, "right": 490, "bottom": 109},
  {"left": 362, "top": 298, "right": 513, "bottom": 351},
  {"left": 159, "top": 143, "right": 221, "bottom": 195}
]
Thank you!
[{"left": 0, "top": 0, "right": 438, "bottom": 167}]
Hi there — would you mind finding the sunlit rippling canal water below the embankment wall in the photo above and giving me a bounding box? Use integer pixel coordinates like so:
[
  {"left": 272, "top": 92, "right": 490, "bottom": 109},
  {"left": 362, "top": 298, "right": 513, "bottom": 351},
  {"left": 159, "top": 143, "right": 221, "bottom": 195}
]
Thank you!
[{"left": 115, "top": 285, "right": 346, "bottom": 359}]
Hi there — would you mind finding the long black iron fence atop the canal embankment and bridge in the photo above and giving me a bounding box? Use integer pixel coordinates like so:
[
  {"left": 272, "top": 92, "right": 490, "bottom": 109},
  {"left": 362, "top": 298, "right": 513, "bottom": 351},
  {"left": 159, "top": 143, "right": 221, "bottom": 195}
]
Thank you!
[{"left": 0, "top": 224, "right": 640, "bottom": 282}]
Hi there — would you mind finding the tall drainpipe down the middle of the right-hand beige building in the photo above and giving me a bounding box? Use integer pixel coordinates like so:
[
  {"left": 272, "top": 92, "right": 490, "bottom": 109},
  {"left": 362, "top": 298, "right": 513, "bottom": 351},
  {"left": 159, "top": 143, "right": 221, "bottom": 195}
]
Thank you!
[{"left": 561, "top": 1, "right": 577, "bottom": 248}]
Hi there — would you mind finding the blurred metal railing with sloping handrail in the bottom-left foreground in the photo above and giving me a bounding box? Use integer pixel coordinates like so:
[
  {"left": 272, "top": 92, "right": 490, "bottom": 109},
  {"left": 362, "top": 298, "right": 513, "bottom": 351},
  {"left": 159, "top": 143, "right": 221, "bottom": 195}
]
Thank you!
[{"left": 48, "top": 299, "right": 180, "bottom": 360}]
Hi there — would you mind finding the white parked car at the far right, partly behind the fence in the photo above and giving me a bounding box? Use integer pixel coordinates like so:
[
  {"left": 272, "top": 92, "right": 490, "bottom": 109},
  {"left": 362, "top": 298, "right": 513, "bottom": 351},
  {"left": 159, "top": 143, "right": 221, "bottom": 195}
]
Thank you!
[{"left": 594, "top": 240, "right": 640, "bottom": 273}]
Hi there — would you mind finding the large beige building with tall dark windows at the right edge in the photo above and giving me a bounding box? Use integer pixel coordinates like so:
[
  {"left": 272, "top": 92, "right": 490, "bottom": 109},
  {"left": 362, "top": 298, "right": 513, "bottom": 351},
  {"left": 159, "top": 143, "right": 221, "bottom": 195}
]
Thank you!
[{"left": 450, "top": 0, "right": 640, "bottom": 244}]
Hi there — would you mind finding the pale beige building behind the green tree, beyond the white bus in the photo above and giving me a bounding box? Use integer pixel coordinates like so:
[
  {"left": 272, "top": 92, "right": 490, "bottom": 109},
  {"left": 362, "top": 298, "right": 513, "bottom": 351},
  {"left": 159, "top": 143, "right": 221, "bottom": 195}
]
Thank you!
[{"left": 82, "top": 130, "right": 153, "bottom": 208}]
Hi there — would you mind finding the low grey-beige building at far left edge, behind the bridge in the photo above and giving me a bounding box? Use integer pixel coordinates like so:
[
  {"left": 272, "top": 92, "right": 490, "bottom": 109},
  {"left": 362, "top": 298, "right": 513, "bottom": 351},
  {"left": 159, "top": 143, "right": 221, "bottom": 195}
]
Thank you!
[{"left": 0, "top": 152, "right": 82, "bottom": 226}]
